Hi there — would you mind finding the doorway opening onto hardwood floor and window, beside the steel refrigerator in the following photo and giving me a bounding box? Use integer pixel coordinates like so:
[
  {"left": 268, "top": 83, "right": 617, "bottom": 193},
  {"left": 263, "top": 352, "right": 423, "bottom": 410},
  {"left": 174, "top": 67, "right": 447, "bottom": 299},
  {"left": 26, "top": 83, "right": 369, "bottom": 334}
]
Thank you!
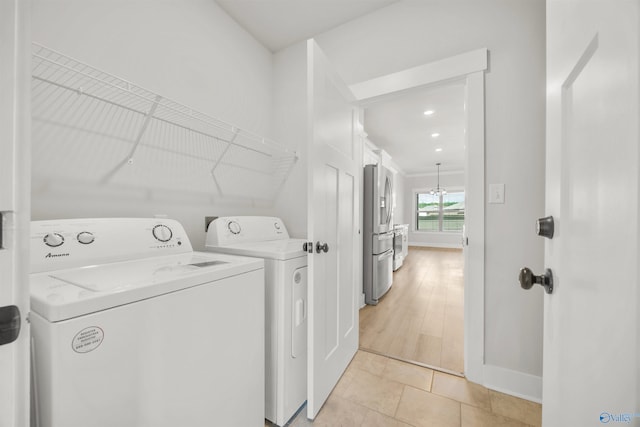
[{"left": 360, "top": 79, "right": 466, "bottom": 375}]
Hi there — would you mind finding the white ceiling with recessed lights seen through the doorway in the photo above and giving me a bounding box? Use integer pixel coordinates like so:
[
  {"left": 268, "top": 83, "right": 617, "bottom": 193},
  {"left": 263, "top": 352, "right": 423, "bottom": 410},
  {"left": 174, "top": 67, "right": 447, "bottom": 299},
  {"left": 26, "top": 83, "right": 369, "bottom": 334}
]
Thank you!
[{"left": 364, "top": 81, "right": 465, "bottom": 175}]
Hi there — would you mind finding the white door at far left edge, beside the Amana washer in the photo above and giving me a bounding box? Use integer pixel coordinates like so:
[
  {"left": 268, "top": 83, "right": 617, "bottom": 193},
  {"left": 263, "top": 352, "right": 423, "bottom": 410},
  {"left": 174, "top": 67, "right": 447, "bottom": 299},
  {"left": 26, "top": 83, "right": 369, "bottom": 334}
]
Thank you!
[{"left": 0, "top": 0, "right": 31, "bottom": 427}]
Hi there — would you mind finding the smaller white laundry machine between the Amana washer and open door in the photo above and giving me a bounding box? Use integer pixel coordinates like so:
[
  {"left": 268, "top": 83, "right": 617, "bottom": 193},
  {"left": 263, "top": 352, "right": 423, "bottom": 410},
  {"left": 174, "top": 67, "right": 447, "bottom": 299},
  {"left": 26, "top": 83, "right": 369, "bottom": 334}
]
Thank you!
[{"left": 206, "top": 216, "right": 307, "bottom": 426}]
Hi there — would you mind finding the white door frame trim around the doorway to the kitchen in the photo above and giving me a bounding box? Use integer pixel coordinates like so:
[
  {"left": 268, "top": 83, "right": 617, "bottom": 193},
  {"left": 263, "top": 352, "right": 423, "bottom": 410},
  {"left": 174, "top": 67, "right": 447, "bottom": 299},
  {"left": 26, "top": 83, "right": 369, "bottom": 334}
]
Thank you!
[{"left": 349, "top": 48, "right": 488, "bottom": 383}]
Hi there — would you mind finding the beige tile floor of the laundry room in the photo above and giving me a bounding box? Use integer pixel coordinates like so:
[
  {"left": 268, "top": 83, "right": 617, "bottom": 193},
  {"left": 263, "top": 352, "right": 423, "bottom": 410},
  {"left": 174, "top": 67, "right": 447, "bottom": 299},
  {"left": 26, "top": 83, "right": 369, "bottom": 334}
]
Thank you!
[{"left": 276, "top": 350, "right": 542, "bottom": 427}]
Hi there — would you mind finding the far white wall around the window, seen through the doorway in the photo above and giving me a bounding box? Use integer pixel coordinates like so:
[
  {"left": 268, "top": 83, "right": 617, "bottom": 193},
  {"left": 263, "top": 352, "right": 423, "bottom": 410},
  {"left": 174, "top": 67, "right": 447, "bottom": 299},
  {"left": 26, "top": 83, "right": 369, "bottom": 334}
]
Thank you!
[{"left": 404, "top": 172, "right": 464, "bottom": 248}]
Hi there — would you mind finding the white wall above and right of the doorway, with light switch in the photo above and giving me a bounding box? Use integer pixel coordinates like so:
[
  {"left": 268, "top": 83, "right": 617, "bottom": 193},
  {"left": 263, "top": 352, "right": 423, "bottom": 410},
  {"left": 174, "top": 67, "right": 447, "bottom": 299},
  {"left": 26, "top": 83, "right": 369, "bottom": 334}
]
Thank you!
[{"left": 316, "top": 0, "right": 545, "bottom": 397}]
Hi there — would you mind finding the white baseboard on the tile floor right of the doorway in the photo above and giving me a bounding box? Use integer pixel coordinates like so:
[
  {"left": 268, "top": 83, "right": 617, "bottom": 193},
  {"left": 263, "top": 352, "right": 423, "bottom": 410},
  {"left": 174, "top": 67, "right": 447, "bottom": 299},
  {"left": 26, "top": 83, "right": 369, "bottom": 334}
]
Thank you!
[{"left": 483, "top": 365, "right": 542, "bottom": 403}]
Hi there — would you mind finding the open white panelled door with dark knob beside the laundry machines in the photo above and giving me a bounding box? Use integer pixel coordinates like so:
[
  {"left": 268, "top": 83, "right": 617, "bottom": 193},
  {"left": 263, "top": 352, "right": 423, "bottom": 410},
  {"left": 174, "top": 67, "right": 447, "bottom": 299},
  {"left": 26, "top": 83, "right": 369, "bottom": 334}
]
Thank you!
[{"left": 307, "top": 40, "right": 362, "bottom": 419}]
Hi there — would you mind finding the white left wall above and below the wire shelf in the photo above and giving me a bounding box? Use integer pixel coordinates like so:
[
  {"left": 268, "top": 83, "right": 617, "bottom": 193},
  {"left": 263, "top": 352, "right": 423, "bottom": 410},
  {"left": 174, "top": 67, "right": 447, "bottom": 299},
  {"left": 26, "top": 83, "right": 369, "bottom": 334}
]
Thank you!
[{"left": 32, "top": 0, "right": 273, "bottom": 249}]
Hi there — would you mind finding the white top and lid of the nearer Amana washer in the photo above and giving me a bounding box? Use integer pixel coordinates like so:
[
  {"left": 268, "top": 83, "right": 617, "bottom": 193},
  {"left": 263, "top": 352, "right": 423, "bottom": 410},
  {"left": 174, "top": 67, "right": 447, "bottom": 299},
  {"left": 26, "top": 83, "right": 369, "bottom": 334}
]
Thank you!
[{"left": 30, "top": 252, "right": 264, "bottom": 322}]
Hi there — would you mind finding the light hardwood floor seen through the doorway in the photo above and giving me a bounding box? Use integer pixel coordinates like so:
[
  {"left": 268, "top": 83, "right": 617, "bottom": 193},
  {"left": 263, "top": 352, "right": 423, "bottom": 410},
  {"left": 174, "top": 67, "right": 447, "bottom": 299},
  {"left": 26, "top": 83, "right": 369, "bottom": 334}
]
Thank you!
[{"left": 360, "top": 247, "right": 464, "bottom": 373}]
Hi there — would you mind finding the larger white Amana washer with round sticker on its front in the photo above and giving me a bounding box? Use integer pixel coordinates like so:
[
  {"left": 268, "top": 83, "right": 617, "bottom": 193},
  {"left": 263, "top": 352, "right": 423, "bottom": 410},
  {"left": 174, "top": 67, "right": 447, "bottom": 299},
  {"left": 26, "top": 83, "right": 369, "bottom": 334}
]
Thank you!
[{"left": 29, "top": 218, "right": 264, "bottom": 427}]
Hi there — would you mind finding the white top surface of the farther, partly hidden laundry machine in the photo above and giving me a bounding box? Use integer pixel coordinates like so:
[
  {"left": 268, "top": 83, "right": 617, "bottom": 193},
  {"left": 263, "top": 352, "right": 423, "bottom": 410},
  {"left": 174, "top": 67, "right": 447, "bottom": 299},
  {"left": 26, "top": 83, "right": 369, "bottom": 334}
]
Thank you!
[{"left": 207, "top": 239, "right": 307, "bottom": 260}]
